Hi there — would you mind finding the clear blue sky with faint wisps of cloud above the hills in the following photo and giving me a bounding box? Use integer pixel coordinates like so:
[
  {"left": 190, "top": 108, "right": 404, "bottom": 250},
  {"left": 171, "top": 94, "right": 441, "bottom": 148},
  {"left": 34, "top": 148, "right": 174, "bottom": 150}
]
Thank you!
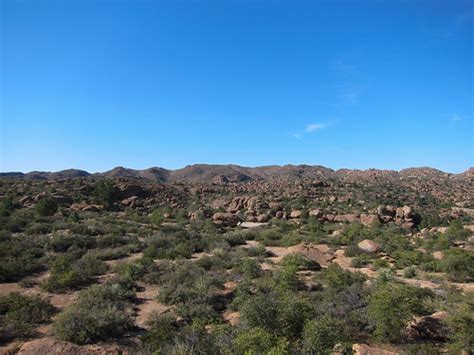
[{"left": 0, "top": 0, "right": 474, "bottom": 172}]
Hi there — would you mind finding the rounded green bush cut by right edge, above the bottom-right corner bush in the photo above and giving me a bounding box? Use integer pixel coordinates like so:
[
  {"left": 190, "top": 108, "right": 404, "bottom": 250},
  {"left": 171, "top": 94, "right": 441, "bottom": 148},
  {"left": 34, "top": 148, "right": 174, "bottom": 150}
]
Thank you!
[{"left": 440, "top": 249, "right": 474, "bottom": 282}]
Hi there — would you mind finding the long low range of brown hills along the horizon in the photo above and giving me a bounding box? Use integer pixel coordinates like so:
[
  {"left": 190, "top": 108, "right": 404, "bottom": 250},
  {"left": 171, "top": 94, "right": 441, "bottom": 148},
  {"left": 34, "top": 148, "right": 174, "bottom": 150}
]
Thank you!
[{"left": 0, "top": 164, "right": 474, "bottom": 184}]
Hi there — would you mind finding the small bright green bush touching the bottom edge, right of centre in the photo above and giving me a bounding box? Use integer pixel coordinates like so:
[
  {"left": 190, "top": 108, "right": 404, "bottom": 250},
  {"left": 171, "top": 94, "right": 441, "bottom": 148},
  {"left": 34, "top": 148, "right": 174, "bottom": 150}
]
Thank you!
[{"left": 302, "top": 315, "right": 347, "bottom": 354}]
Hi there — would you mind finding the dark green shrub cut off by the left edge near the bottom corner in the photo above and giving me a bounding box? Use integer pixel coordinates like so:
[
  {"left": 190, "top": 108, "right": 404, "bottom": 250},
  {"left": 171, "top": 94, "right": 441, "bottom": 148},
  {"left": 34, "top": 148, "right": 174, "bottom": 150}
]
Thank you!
[{"left": 0, "top": 293, "right": 54, "bottom": 341}]
